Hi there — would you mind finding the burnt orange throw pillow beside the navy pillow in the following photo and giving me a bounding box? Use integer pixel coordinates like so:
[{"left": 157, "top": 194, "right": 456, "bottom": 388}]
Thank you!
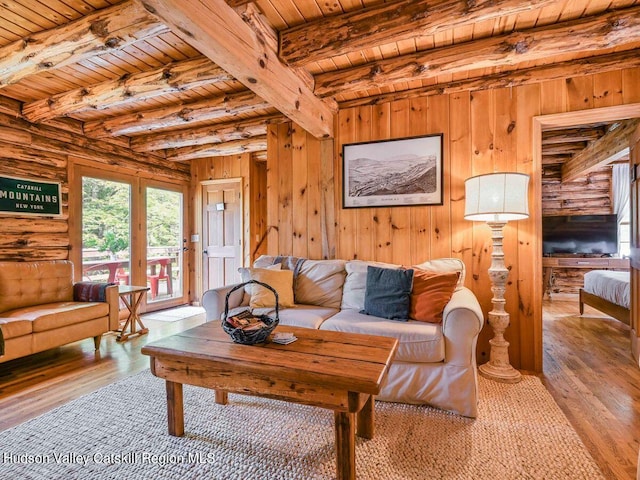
[{"left": 409, "top": 267, "right": 460, "bottom": 323}]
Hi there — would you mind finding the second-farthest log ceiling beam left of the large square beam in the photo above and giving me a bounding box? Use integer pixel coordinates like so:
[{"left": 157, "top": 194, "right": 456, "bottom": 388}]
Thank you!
[{"left": 130, "top": 113, "right": 286, "bottom": 152}]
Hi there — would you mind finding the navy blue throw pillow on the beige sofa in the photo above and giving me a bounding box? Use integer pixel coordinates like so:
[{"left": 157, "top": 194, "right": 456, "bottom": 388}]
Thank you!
[{"left": 360, "top": 266, "right": 413, "bottom": 321}]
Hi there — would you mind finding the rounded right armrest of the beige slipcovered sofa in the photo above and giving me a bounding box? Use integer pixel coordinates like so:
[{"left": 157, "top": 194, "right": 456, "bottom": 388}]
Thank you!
[{"left": 442, "top": 287, "right": 484, "bottom": 366}]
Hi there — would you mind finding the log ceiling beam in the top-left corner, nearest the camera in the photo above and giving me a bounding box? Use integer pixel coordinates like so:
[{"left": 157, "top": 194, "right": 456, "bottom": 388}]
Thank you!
[{"left": 0, "top": 0, "right": 169, "bottom": 88}]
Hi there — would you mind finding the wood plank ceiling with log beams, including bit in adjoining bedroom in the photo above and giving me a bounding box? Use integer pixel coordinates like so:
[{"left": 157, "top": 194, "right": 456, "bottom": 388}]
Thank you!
[{"left": 0, "top": 0, "right": 640, "bottom": 169}]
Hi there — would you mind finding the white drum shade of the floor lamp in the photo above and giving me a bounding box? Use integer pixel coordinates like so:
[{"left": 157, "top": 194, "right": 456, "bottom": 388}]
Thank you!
[{"left": 464, "top": 172, "right": 529, "bottom": 222}]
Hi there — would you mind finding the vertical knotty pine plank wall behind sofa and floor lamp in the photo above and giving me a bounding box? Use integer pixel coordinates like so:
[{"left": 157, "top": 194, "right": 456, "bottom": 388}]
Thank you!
[{"left": 267, "top": 69, "right": 640, "bottom": 371}]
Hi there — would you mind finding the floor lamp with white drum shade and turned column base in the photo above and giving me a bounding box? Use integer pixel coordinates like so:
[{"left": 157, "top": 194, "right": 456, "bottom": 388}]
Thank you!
[{"left": 464, "top": 172, "right": 529, "bottom": 383}]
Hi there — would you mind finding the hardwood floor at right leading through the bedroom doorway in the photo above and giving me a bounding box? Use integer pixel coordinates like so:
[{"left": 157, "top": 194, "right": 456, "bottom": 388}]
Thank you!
[{"left": 542, "top": 299, "right": 640, "bottom": 480}]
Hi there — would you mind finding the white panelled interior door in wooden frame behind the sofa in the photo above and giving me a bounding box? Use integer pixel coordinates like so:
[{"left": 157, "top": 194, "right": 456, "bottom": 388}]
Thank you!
[{"left": 202, "top": 179, "right": 243, "bottom": 291}]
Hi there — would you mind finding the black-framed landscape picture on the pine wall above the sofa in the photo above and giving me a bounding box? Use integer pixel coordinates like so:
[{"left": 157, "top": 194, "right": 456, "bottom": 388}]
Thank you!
[{"left": 342, "top": 133, "right": 443, "bottom": 208}]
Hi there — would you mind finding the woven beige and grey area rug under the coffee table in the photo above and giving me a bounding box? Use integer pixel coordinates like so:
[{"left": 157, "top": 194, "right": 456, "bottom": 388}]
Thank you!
[{"left": 0, "top": 370, "right": 603, "bottom": 480}]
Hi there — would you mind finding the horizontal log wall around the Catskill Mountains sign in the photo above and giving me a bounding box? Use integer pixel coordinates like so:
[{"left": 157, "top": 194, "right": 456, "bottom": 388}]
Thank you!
[{"left": 0, "top": 104, "right": 190, "bottom": 261}]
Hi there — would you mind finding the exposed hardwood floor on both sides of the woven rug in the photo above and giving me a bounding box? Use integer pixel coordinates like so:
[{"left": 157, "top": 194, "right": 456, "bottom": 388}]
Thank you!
[{"left": 0, "top": 300, "right": 640, "bottom": 480}]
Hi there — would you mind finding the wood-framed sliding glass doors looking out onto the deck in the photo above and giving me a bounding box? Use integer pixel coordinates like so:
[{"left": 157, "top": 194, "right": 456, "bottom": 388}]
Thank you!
[{"left": 69, "top": 165, "right": 188, "bottom": 312}]
